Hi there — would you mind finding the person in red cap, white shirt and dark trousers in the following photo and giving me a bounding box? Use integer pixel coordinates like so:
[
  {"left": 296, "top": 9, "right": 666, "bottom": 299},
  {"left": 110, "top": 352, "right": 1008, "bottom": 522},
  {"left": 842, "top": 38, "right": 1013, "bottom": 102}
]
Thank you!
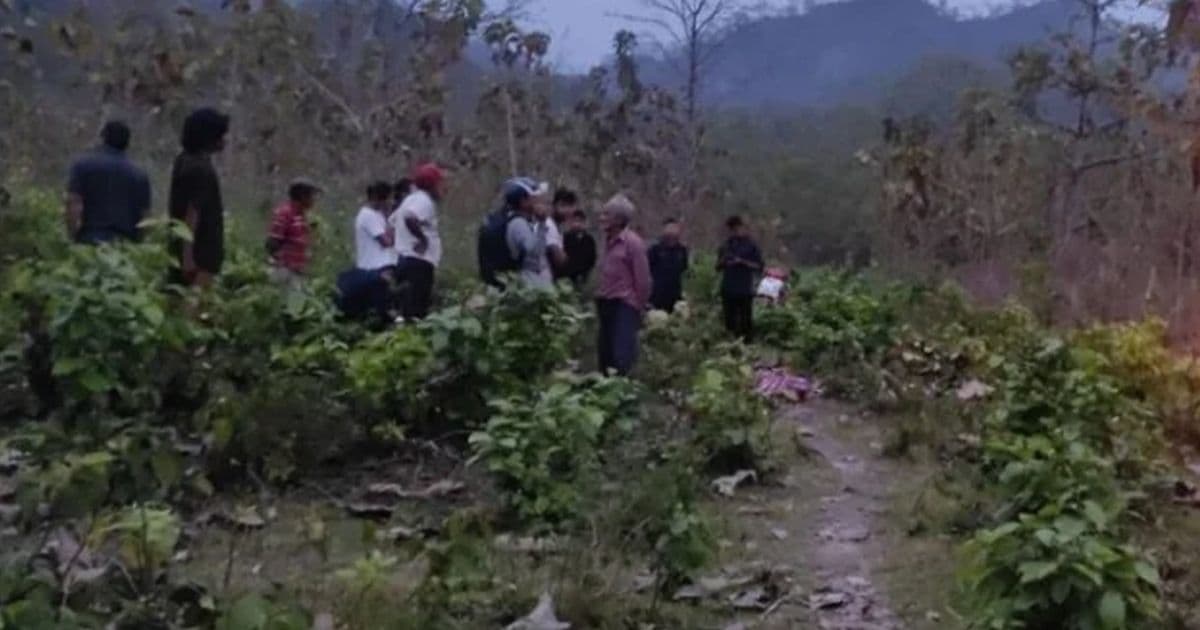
[{"left": 388, "top": 163, "right": 445, "bottom": 319}]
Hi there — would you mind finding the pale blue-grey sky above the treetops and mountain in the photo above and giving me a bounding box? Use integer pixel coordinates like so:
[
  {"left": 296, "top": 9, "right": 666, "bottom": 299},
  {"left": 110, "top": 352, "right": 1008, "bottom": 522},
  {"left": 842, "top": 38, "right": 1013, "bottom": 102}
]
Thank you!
[{"left": 529, "top": 0, "right": 1010, "bottom": 71}]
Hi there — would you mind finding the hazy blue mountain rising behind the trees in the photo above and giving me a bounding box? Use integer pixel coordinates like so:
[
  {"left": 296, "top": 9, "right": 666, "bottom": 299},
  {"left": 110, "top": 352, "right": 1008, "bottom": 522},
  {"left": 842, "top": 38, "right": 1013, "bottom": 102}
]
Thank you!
[{"left": 647, "top": 0, "right": 1076, "bottom": 107}]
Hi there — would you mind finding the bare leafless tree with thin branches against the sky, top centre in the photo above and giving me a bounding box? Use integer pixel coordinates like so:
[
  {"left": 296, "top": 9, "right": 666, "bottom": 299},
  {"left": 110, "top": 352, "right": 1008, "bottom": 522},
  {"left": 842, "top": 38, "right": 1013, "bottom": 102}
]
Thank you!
[{"left": 622, "top": 0, "right": 742, "bottom": 127}]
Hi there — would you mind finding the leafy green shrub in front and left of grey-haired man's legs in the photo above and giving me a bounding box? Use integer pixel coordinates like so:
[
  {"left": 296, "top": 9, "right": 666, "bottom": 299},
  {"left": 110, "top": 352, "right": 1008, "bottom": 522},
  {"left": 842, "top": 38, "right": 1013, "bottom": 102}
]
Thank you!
[{"left": 470, "top": 376, "right": 629, "bottom": 527}]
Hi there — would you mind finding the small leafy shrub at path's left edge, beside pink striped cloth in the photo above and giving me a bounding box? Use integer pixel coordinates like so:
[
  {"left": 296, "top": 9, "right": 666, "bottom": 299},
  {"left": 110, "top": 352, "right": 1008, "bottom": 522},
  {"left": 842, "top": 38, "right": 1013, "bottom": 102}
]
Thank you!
[{"left": 688, "top": 348, "right": 770, "bottom": 472}]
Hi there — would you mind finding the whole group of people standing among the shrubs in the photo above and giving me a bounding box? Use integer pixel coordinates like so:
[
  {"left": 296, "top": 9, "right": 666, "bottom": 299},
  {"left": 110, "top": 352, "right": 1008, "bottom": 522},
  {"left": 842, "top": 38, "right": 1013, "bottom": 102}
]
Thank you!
[{"left": 66, "top": 108, "right": 778, "bottom": 374}]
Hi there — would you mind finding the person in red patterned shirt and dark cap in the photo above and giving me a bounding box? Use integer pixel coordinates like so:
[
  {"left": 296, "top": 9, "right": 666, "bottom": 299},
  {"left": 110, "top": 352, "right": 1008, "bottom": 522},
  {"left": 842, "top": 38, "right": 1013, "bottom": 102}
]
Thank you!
[{"left": 266, "top": 178, "right": 320, "bottom": 287}]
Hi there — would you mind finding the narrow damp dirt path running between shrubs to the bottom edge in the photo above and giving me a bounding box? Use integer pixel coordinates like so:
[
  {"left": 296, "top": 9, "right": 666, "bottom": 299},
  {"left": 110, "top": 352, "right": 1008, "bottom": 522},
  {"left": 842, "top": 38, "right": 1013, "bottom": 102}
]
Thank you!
[{"left": 705, "top": 402, "right": 956, "bottom": 630}]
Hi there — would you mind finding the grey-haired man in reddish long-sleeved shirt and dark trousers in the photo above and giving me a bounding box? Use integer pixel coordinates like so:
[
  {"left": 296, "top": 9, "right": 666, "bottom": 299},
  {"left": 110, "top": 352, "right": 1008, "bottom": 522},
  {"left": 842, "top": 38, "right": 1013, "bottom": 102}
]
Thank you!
[{"left": 596, "top": 194, "right": 650, "bottom": 376}]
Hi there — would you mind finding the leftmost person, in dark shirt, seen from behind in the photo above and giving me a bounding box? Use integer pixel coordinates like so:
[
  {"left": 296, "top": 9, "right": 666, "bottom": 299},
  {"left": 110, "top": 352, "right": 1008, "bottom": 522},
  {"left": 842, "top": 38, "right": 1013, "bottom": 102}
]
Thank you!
[{"left": 66, "top": 120, "right": 150, "bottom": 245}]
